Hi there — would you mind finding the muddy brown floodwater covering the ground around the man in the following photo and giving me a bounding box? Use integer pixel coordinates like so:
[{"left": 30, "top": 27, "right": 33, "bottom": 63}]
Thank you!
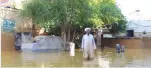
[{"left": 2, "top": 48, "right": 151, "bottom": 68}]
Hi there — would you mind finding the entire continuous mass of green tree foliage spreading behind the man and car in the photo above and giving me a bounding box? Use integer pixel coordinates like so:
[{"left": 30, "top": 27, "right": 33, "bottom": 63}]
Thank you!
[{"left": 20, "top": 0, "right": 126, "bottom": 49}]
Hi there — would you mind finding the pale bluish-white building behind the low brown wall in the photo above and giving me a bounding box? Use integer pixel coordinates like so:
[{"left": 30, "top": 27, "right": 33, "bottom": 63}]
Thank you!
[{"left": 127, "top": 20, "right": 151, "bottom": 37}]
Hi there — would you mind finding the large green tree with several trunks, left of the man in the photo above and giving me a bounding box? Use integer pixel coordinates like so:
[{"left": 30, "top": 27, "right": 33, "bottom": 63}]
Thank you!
[{"left": 21, "top": 0, "right": 93, "bottom": 48}]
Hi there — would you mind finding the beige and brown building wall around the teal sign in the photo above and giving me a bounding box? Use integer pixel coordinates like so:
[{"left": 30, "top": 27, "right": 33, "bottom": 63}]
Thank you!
[{"left": 0, "top": 8, "right": 32, "bottom": 51}]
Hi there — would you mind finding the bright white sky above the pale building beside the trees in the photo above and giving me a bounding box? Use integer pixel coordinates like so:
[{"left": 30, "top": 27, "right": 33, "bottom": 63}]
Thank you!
[{"left": 117, "top": 0, "right": 151, "bottom": 20}]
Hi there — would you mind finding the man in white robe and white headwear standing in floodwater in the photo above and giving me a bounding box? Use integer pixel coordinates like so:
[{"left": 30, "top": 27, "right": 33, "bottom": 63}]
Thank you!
[{"left": 81, "top": 28, "right": 96, "bottom": 60}]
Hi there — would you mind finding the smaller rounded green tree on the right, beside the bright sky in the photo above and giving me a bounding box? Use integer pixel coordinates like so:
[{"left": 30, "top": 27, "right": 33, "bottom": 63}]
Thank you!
[{"left": 99, "top": 0, "right": 127, "bottom": 35}]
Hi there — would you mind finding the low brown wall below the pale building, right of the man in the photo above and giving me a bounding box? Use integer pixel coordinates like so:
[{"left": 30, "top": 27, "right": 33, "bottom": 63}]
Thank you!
[{"left": 101, "top": 38, "right": 142, "bottom": 48}]
